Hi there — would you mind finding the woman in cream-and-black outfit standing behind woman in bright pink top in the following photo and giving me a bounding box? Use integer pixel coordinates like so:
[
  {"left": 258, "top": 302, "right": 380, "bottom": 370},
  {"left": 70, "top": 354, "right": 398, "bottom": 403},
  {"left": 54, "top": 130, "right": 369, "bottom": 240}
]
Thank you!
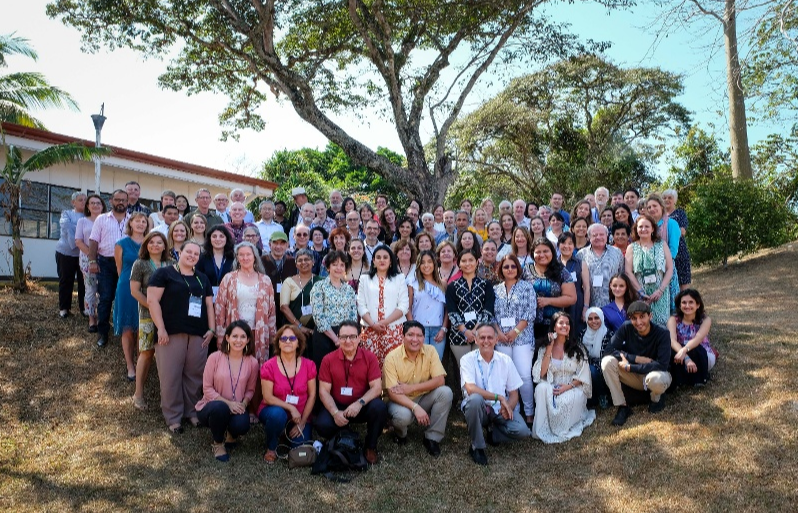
[{"left": 281, "top": 248, "right": 322, "bottom": 344}]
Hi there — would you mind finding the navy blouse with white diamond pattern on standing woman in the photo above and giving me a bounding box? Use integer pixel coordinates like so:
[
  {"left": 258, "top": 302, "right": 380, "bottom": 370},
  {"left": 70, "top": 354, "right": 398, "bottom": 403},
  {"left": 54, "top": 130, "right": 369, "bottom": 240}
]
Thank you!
[{"left": 445, "top": 276, "right": 495, "bottom": 346}]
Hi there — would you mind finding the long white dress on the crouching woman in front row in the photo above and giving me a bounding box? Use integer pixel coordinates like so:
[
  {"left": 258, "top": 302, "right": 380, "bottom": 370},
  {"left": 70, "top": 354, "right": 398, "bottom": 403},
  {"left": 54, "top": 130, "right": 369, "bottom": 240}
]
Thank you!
[{"left": 532, "top": 347, "right": 595, "bottom": 444}]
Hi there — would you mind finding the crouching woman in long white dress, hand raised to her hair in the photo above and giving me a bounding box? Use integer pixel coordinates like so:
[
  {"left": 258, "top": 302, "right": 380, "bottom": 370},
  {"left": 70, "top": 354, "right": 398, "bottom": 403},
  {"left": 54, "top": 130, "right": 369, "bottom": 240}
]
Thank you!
[{"left": 532, "top": 312, "right": 595, "bottom": 444}]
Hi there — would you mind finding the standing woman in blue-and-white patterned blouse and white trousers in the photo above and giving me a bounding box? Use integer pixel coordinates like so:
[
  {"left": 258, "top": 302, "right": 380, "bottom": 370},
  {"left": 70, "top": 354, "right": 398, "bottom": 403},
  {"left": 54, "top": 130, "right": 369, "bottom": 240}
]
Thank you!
[{"left": 494, "top": 255, "right": 536, "bottom": 424}]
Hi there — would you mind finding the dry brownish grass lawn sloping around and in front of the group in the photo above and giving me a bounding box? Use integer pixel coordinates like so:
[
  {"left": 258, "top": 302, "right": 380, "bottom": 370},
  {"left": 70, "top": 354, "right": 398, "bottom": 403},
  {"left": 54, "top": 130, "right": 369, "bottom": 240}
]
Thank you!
[{"left": 0, "top": 243, "right": 798, "bottom": 512}]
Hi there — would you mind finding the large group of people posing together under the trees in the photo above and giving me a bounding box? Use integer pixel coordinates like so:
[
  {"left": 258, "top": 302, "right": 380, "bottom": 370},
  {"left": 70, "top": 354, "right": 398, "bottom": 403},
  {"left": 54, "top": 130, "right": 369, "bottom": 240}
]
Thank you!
[{"left": 56, "top": 182, "right": 718, "bottom": 465}]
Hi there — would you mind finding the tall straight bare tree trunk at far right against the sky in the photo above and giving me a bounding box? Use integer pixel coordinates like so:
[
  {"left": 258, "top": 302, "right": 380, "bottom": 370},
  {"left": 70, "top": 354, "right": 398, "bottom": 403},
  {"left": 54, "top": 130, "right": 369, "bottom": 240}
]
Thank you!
[{"left": 723, "top": 0, "right": 753, "bottom": 180}]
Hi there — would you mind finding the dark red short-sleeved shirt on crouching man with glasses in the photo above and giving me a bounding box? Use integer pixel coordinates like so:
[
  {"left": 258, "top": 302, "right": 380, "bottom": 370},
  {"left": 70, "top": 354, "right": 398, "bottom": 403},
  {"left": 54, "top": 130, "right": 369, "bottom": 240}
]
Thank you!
[{"left": 319, "top": 347, "right": 381, "bottom": 407}]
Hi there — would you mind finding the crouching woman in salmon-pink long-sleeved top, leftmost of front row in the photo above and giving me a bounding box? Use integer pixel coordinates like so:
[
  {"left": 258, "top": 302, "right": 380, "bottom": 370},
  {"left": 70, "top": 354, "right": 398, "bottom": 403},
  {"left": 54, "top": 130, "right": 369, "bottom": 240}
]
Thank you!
[{"left": 194, "top": 321, "right": 258, "bottom": 462}]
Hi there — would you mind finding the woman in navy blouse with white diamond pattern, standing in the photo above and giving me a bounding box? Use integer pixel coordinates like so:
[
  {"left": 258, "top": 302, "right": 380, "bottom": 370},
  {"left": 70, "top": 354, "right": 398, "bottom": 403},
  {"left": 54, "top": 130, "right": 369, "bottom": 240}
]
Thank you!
[{"left": 445, "top": 250, "right": 495, "bottom": 366}]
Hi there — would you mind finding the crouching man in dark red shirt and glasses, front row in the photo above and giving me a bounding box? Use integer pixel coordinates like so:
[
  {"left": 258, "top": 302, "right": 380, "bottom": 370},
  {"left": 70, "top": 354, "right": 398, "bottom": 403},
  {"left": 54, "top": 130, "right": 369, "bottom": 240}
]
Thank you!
[{"left": 315, "top": 321, "right": 389, "bottom": 465}]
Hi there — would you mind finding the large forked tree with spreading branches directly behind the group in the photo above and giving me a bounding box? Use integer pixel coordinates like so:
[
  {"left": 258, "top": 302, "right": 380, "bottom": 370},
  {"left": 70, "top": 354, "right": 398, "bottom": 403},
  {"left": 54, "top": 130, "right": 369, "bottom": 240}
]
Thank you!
[{"left": 47, "top": 0, "right": 633, "bottom": 206}]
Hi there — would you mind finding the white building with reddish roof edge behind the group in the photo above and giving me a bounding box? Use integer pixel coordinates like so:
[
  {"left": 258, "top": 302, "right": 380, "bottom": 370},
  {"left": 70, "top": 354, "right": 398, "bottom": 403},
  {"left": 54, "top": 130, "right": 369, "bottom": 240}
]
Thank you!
[{"left": 0, "top": 123, "right": 278, "bottom": 279}]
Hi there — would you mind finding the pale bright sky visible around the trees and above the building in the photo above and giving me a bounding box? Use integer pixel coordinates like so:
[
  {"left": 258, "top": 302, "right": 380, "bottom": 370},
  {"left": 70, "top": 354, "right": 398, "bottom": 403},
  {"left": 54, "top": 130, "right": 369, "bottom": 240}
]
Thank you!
[{"left": 0, "top": 0, "right": 780, "bottom": 179}]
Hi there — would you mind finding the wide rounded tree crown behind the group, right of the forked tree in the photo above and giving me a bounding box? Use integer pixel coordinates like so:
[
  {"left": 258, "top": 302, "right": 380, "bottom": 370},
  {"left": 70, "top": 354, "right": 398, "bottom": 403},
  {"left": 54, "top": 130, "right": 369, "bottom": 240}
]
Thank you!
[{"left": 454, "top": 54, "right": 689, "bottom": 200}]
